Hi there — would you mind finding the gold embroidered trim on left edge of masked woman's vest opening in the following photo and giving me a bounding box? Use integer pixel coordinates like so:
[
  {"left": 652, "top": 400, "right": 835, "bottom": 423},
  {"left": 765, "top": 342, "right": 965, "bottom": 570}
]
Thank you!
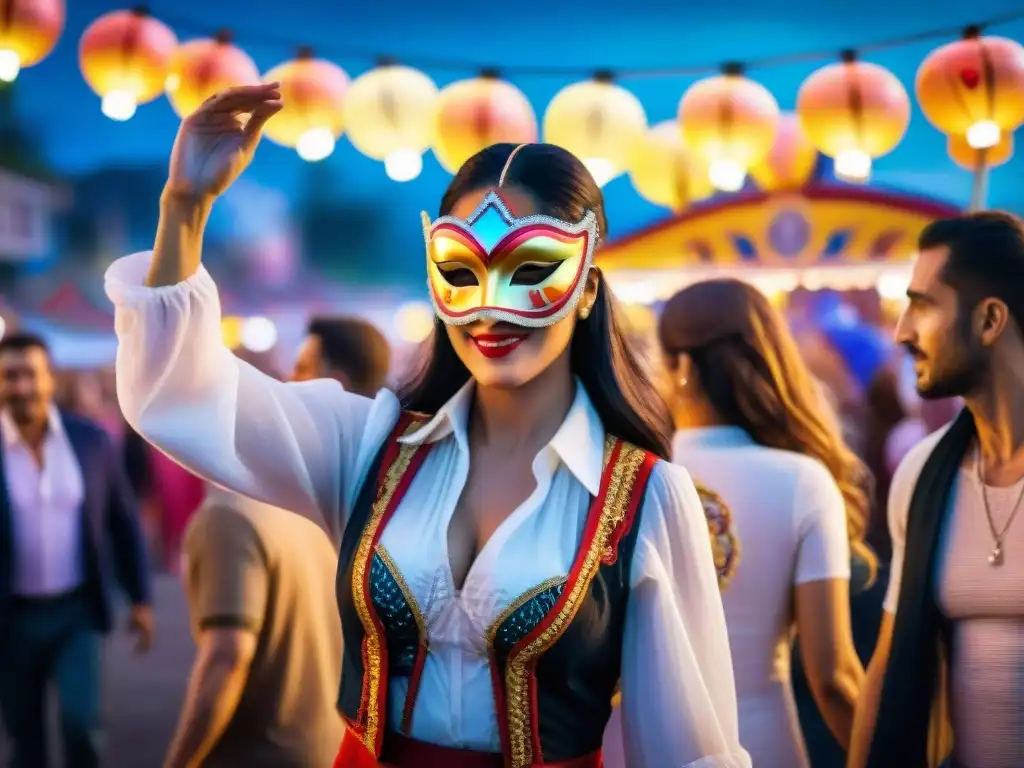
[{"left": 352, "top": 421, "right": 422, "bottom": 755}]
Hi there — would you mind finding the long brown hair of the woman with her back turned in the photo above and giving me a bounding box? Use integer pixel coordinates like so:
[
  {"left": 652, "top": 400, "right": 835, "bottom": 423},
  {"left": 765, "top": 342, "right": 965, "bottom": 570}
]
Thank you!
[{"left": 658, "top": 280, "right": 878, "bottom": 581}]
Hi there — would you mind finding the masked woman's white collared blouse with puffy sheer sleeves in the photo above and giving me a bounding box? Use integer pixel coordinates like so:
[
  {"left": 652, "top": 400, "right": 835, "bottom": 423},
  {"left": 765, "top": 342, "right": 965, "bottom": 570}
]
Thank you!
[{"left": 106, "top": 253, "right": 751, "bottom": 768}]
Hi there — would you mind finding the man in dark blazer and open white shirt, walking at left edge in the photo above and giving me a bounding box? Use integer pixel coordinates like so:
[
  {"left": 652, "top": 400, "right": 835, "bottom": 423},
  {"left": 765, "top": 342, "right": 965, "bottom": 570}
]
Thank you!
[{"left": 0, "top": 333, "right": 153, "bottom": 768}]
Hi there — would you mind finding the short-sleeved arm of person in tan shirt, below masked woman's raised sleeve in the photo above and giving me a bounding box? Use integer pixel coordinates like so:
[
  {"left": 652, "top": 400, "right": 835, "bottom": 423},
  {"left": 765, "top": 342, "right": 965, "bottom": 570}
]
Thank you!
[{"left": 164, "top": 505, "right": 268, "bottom": 768}]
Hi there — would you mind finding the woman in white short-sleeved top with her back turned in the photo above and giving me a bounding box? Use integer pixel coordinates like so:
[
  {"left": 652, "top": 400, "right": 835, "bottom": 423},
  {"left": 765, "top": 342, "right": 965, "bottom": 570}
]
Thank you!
[{"left": 658, "top": 280, "right": 874, "bottom": 768}]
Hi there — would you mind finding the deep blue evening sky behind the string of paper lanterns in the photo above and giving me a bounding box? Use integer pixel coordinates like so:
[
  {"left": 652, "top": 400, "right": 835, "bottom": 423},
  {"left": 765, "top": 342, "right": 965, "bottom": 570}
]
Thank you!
[{"left": 9, "top": 0, "right": 1024, "bottom": 276}]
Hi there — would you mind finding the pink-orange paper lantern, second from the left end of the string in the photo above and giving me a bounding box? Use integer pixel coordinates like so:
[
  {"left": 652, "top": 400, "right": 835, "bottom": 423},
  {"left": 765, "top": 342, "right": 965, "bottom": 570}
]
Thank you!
[{"left": 78, "top": 8, "right": 178, "bottom": 120}]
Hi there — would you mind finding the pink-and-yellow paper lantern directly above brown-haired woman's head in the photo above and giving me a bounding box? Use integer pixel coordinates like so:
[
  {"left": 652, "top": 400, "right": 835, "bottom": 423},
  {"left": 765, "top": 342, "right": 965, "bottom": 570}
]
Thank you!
[{"left": 679, "top": 66, "right": 779, "bottom": 191}]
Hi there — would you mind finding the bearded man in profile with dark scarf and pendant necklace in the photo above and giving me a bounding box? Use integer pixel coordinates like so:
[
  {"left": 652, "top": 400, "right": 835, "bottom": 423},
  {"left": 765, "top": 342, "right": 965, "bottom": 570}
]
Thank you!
[{"left": 849, "top": 212, "right": 1024, "bottom": 768}]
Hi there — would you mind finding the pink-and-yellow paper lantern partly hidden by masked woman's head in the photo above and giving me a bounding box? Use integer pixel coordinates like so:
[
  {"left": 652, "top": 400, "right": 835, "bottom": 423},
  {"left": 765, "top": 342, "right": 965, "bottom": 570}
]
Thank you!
[{"left": 433, "top": 72, "right": 537, "bottom": 173}]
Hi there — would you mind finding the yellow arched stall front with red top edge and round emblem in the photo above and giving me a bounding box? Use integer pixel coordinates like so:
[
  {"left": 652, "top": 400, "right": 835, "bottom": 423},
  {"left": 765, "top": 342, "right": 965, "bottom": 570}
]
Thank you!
[{"left": 598, "top": 180, "right": 959, "bottom": 313}]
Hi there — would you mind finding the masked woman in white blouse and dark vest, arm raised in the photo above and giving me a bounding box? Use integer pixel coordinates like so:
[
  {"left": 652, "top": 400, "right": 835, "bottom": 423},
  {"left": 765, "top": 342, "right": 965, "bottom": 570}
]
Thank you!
[{"left": 106, "top": 84, "right": 750, "bottom": 768}]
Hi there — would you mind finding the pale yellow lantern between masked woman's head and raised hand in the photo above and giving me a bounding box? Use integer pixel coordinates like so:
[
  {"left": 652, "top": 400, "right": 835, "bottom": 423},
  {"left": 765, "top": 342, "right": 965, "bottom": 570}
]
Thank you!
[{"left": 345, "top": 63, "right": 437, "bottom": 181}]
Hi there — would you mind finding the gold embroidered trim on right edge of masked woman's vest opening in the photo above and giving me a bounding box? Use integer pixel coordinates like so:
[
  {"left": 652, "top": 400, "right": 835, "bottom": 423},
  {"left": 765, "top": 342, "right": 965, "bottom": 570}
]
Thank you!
[{"left": 505, "top": 437, "right": 645, "bottom": 768}]
